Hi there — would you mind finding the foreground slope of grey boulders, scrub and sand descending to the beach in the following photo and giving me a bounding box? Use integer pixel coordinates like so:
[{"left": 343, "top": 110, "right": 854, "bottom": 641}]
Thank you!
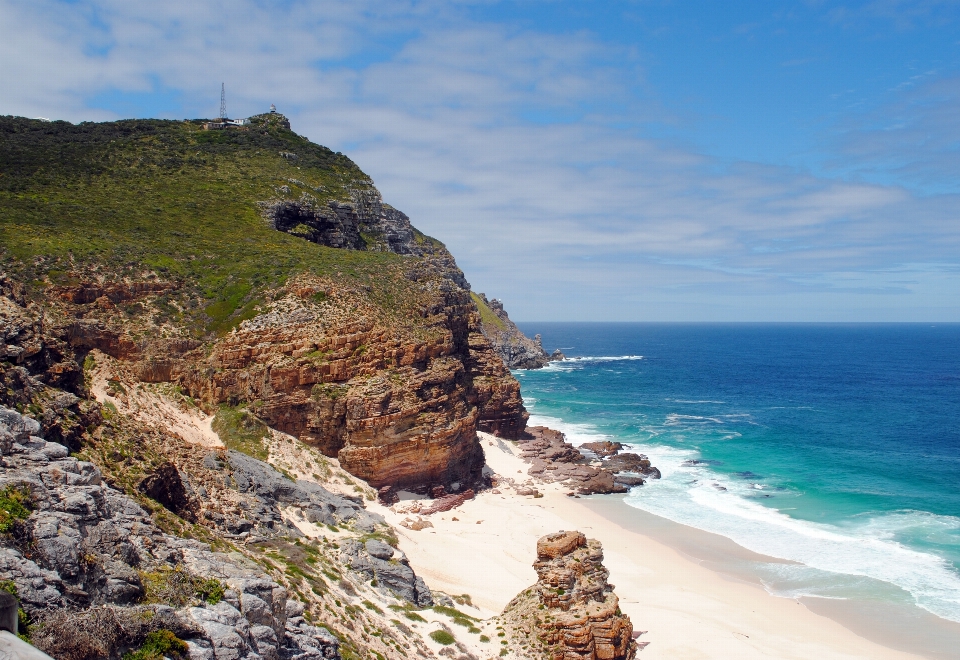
[{"left": 0, "top": 287, "right": 446, "bottom": 660}]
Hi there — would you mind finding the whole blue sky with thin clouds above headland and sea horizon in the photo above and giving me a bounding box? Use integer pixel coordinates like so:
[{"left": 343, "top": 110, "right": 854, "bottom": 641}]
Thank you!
[{"left": 0, "top": 0, "right": 960, "bottom": 322}]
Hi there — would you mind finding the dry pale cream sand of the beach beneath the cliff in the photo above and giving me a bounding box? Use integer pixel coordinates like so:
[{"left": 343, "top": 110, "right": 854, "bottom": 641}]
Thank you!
[{"left": 373, "top": 434, "right": 954, "bottom": 660}]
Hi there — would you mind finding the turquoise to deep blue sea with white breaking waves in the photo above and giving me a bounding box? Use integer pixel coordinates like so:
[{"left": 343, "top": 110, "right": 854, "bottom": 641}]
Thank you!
[{"left": 515, "top": 323, "right": 960, "bottom": 621}]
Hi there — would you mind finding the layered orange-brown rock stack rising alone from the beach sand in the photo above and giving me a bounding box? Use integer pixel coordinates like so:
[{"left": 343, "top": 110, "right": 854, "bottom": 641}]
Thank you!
[{"left": 500, "top": 532, "right": 637, "bottom": 660}]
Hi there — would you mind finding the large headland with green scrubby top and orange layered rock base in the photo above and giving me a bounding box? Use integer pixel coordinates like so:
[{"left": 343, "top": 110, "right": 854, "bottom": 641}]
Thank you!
[{"left": 0, "top": 117, "right": 527, "bottom": 492}]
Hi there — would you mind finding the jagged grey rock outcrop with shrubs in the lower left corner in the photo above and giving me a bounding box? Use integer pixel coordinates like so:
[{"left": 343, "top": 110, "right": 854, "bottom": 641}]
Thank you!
[{"left": 0, "top": 407, "right": 340, "bottom": 660}]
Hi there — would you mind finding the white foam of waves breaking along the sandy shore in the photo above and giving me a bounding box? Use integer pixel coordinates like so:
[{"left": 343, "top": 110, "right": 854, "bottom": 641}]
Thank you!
[{"left": 626, "top": 445, "right": 960, "bottom": 621}]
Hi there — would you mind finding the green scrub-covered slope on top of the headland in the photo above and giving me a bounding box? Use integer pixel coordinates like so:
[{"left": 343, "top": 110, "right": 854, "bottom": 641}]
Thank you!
[{"left": 0, "top": 115, "right": 439, "bottom": 334}]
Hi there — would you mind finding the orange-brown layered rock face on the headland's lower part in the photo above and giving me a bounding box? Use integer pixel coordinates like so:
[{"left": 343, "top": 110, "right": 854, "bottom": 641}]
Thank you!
[{"left": 60, "top": 270, "right": 528, "bottom": 492}]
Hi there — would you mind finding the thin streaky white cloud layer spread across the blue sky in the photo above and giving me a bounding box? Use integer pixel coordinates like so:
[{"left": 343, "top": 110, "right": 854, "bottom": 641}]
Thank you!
[{"left": 0, "top": 0, "right": 960, "bottom": 320}]
